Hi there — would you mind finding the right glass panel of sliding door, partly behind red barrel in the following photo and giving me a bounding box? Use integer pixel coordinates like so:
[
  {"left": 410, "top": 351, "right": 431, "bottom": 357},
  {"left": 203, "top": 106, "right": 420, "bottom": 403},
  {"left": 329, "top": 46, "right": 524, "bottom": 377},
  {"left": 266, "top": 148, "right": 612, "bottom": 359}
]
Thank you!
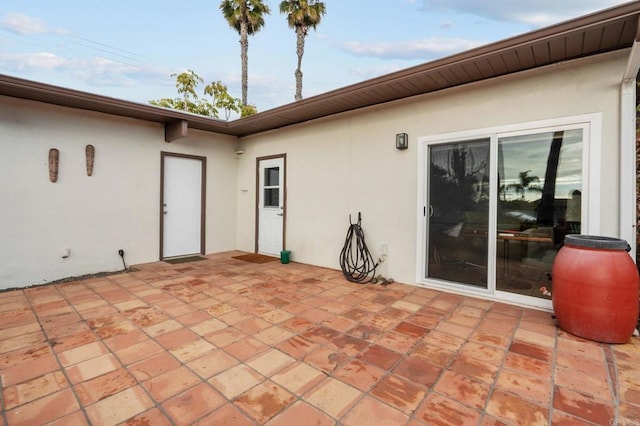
[{"left": 496, "top": 129, "right": 583, "bottom": 298}]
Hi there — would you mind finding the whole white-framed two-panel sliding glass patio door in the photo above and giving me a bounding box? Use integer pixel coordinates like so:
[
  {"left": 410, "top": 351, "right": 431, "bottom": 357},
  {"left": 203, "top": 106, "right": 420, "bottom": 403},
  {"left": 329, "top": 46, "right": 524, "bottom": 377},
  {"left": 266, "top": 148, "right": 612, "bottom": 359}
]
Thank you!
[{"left": 422, "top": 123, "right": 590, "bottom": 306}]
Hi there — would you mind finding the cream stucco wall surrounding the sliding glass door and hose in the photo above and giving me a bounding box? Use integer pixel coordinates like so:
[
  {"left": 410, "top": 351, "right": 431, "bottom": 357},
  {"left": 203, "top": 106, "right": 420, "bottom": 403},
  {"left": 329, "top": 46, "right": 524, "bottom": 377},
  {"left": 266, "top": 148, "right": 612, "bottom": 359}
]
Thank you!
[{"left": 238, "top": 52, "right": 627, "bottom": 283}]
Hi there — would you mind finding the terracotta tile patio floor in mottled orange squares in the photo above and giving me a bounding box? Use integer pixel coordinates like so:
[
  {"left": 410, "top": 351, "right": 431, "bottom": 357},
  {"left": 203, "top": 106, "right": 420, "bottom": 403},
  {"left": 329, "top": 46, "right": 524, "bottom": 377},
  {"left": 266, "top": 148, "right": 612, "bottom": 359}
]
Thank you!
[{"left": 0, "top": 252, "right": 640, "bottom": 426}]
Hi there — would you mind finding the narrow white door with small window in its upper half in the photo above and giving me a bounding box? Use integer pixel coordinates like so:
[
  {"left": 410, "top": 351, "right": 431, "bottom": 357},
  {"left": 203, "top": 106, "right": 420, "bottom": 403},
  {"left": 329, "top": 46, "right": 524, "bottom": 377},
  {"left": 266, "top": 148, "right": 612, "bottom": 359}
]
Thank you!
[{"left": 258, "top": 157, "right": 285, "bottom": 256}]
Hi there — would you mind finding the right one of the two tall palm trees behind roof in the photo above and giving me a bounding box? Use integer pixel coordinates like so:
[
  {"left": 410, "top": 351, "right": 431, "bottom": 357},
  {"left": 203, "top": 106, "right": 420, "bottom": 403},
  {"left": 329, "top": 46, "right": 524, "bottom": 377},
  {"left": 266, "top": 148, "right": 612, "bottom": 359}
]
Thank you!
[{"left": 280, "top": 0, "right": 326, "bottom": 101}]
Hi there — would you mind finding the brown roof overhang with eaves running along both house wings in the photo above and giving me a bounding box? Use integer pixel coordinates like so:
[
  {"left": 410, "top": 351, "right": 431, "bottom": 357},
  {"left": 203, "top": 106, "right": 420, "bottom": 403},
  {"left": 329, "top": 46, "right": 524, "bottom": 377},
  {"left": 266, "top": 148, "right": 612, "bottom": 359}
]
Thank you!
[{"left": 0, "top": 1, "right": 640, "bottom": 137}]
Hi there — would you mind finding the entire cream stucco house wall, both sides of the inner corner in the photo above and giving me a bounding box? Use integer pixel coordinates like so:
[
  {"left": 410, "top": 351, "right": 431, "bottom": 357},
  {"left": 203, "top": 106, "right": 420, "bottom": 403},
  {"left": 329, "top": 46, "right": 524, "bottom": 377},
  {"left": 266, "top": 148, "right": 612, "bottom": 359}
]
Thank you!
[{"left": 0, "top": 52, "right": 628, "bottom": 288}]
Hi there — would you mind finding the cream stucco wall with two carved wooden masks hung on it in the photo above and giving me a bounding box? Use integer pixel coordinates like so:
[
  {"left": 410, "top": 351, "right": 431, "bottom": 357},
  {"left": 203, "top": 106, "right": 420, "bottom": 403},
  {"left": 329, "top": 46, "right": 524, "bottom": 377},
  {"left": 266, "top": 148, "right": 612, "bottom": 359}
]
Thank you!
[{"left": 0, "top": 97, "right": 237, "bottom": 288}]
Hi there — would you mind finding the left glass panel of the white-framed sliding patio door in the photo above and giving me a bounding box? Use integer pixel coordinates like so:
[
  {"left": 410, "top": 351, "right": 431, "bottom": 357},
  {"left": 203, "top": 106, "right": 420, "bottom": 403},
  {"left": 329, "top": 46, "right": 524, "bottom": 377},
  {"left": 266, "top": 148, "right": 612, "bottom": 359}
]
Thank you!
[{"left": 426, "top": 139, "right": 491, "bottom": 288}]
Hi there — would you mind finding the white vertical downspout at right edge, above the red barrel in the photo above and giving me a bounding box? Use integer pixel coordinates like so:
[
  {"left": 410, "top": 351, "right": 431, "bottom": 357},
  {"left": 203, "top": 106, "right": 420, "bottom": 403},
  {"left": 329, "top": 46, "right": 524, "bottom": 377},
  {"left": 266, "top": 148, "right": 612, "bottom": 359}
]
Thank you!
[{"left": 619, "top": 22, "right": 640, "bottom": 261}]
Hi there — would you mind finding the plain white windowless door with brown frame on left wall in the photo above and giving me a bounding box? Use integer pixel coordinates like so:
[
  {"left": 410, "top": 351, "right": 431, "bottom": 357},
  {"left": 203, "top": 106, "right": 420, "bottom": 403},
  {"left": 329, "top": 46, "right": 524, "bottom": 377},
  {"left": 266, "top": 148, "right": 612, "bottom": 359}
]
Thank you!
[{"left": 161, "top": 153, "right": 205, "bottom": 259}]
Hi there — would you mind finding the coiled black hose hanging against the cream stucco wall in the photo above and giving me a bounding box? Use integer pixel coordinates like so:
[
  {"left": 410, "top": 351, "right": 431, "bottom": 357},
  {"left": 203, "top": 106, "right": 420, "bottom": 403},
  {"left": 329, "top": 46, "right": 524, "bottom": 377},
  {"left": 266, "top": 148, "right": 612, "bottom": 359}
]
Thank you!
[{"left": 340, "top": 213, "right": 378, "bottom": 283}]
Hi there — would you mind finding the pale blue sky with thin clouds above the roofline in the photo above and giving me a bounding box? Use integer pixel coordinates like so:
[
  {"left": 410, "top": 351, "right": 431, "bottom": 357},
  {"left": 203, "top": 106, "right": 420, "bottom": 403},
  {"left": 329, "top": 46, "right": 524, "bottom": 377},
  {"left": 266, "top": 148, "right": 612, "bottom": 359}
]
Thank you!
[{"left": 0, "top": 0, "right": 626, "bottom": 111}]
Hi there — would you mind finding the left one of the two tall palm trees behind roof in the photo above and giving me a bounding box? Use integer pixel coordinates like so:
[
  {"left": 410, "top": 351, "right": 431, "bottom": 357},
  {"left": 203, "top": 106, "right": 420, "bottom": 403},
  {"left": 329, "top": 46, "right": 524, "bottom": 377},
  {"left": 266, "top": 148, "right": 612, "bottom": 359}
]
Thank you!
[{"left": 220, "top": 0, "right": 271, "bottom": 105}]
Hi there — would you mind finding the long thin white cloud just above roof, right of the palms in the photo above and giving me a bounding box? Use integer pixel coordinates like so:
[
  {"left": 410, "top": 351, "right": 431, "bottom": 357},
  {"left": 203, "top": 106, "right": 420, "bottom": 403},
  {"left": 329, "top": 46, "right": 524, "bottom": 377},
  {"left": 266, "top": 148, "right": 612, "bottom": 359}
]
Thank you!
[{"left": 340, "top": 38, "right": 486, "bottom": 60}]
